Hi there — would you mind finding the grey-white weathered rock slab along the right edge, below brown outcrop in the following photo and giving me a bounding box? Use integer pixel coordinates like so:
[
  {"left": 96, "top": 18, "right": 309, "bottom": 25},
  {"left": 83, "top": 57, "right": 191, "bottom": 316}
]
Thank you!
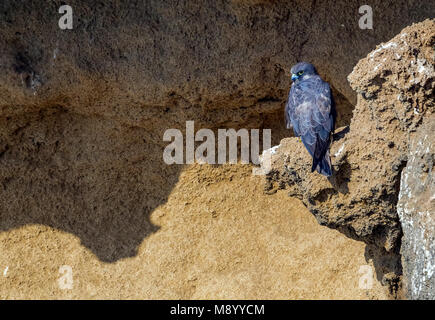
[{"left": 397, "top": 115, "right": 435, "bottom": 300}]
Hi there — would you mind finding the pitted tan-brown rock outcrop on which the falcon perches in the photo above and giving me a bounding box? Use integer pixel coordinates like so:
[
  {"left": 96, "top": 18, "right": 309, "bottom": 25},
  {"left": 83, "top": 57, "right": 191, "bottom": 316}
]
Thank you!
[{"left": 266, "top": 20, "right": 435, "bottom": 292}]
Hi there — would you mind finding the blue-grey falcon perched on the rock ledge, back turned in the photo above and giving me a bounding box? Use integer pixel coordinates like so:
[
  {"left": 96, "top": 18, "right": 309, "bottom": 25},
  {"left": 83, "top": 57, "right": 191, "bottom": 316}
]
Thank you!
[{"left": 285, "top": 62, "right": 337, "bottom": 177}]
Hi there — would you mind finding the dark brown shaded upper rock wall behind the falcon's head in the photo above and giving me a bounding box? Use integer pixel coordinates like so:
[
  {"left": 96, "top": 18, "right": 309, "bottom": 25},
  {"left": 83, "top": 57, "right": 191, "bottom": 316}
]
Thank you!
[{"left": 0, "top": 0, "right": 435, "bottom": 128}]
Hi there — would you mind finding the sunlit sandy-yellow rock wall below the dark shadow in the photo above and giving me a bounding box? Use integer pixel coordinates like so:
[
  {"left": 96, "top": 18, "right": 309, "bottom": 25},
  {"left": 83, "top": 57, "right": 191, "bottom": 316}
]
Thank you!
[{"left": 0, "top": 165, "right": 391, "bottom": 299}]
